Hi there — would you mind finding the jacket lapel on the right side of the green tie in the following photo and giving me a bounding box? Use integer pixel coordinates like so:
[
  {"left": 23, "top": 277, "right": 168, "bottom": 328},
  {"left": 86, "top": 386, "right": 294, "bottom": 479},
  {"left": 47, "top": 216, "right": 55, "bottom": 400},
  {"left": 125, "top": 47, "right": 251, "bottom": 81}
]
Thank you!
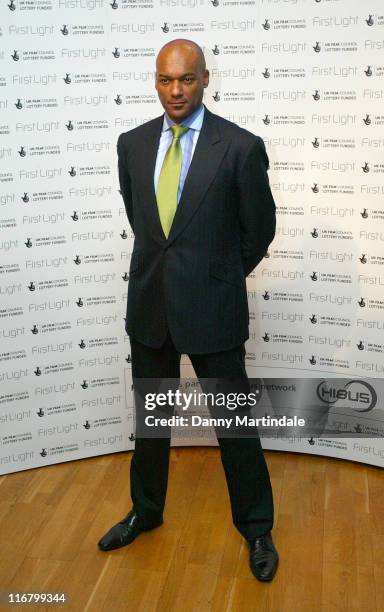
[{"left": 167, "top": 109, "right": 229, "bottom": 242}]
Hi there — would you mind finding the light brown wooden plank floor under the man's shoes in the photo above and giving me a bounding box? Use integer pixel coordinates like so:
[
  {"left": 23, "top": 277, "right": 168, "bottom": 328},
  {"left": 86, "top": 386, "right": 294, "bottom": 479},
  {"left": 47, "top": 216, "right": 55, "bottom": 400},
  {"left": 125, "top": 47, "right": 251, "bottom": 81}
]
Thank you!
[{"left": 0, "top": 448, "right": 384, "bottom": 612}]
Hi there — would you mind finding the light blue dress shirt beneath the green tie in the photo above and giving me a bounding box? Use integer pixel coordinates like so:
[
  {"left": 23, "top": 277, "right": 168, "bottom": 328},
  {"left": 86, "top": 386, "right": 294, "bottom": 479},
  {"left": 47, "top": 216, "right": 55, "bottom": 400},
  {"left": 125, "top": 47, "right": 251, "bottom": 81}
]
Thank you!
[{"left": 154, "top": 105, "right": 204, "bottom": 203}]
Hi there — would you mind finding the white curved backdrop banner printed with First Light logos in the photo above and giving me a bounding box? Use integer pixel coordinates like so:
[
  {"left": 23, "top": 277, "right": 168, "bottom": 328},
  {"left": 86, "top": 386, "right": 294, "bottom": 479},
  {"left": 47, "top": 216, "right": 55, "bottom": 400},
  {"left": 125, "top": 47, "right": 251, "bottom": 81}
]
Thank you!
[{"left": 0, "top": 0, "right": 384, "bottom": 474}]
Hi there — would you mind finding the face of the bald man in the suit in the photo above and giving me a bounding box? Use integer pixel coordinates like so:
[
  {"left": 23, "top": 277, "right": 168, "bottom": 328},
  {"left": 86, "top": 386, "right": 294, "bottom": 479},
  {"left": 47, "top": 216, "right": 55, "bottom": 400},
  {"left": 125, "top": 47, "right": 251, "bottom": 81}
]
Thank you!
[{"left": 156, "top": 45, "right": 209, "bottom": 123}]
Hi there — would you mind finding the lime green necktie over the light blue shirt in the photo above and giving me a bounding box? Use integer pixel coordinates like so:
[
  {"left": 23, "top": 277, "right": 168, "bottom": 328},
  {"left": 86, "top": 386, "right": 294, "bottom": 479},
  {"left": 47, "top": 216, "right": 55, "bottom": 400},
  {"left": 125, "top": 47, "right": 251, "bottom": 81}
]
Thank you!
[{"left": 156, "top": 125, "right": 189, "bottom": 238}]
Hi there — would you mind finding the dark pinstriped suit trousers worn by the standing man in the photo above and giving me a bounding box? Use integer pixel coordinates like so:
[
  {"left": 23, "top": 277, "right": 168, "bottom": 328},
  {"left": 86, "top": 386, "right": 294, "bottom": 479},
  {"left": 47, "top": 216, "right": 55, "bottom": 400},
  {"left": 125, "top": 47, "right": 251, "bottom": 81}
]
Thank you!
[{"left": 131, "top": 334, "right": 273, "bottom": 541}]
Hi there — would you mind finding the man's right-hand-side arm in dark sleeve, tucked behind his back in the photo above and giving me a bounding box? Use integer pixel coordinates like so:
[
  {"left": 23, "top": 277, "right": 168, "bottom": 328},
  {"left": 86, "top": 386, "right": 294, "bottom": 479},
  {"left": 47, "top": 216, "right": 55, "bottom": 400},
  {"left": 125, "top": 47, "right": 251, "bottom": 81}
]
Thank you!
[{"left": 239, "top": 137, "right": 276, "bottom": 276}]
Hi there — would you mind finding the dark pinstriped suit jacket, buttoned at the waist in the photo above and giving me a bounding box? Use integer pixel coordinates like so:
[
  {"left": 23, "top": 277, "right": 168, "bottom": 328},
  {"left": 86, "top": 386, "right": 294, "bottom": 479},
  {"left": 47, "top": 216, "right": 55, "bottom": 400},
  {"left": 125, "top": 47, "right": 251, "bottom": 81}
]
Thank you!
[{"left": 117, "top": 109, "right": 275, "bottom": 354}]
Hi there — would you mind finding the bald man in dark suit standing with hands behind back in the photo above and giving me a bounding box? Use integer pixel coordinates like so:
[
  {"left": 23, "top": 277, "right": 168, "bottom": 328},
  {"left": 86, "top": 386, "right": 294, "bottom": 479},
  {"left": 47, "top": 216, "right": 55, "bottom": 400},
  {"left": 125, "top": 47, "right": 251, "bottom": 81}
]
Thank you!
[{"left": 99, "top": 40, "right": 278, "bottom": 581}]
